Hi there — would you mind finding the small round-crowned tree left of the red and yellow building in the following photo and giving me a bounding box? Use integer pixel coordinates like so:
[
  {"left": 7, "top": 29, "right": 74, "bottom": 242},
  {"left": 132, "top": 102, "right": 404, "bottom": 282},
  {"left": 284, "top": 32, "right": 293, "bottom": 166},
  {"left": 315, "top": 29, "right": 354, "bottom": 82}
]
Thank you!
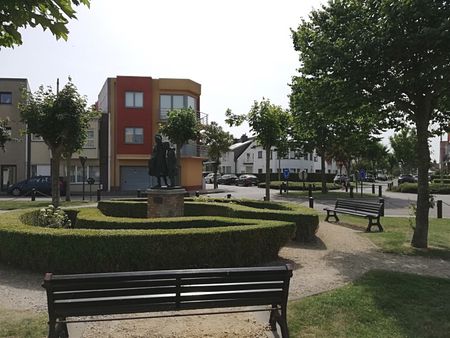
[{"left": 19, "top": 79, "right": 95, "bottom": 207}]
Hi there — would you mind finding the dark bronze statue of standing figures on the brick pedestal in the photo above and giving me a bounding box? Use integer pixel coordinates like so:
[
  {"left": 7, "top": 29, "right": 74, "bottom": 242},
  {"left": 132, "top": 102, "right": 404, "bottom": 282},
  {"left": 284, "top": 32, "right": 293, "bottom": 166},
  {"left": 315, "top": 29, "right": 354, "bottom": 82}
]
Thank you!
[{"left": 148, "top": 135, "right": 178, "bottom": 189}]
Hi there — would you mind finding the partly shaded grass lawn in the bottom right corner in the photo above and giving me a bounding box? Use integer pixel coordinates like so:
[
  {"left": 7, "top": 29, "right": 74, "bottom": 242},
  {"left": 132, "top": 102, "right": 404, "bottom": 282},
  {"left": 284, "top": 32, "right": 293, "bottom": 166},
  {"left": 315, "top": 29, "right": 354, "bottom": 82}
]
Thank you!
[{"left": 288, "top": 271, "right": 450, "bottom": 337}]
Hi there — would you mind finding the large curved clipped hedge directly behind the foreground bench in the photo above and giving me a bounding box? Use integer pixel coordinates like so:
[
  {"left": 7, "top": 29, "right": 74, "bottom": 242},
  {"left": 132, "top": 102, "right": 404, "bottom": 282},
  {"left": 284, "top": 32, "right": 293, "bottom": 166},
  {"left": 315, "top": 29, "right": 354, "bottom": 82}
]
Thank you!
[{"left": 0, "top": 208, "right": 295, "bottom": 273}]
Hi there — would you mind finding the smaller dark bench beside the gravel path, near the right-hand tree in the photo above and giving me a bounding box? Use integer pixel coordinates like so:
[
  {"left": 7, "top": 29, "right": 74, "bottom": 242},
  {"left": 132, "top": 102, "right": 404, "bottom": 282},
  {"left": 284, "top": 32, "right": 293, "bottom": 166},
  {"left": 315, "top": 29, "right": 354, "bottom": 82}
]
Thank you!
[{"left": 324, "top": 198, "right": 383, "bottom": 232}]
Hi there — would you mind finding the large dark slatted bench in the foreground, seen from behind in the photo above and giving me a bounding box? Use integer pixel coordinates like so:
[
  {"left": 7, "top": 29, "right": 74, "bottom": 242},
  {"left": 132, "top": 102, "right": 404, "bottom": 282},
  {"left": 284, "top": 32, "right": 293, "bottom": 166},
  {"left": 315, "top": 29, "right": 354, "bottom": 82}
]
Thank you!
[{"left": 42, "top": 265, "right": 292, "bottom": 337}]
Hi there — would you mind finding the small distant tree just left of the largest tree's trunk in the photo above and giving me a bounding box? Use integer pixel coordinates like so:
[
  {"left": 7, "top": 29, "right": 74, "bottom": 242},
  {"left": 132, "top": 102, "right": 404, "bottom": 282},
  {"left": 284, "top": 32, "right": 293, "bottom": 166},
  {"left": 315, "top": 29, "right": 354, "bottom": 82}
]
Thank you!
[{"left": 389, "top": 128, "right": 419, "bottom": 174}]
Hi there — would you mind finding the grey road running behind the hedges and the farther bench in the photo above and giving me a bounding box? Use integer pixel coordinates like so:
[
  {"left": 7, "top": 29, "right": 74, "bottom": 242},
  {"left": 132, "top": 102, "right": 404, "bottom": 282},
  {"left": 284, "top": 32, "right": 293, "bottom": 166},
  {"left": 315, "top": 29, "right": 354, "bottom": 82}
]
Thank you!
[{"left": 206, "top": 182, "right": 450, "bottom": 218}]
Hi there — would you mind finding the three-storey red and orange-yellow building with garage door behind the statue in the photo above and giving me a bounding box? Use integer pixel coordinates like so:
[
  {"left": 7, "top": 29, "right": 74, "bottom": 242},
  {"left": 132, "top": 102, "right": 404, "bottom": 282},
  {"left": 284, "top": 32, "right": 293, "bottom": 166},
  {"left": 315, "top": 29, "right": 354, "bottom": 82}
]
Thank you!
[{"left": 97, "top": 76, "right": 205, "bottom": 191}]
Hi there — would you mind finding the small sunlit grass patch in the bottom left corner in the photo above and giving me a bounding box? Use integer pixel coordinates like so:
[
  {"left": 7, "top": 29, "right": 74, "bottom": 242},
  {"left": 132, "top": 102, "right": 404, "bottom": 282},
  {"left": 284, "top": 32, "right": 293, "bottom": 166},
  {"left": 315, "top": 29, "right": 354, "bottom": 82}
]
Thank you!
[{"left": 0, "top": 309, "right": 48, "bottom": 338}]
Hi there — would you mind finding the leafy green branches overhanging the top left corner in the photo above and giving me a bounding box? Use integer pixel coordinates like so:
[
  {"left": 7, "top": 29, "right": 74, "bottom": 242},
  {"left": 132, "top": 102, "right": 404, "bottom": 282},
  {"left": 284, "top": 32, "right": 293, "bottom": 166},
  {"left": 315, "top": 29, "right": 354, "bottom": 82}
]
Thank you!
[{"left": 0, "top": 0, "right": 90, "bottom": 47}]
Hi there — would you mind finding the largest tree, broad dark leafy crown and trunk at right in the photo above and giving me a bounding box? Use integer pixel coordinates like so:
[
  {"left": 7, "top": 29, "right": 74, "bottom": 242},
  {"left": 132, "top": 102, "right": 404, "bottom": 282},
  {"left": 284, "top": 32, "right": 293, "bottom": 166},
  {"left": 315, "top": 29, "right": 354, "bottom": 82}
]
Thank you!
[{"left": 294, "top": 0, "right": 450, "bottom": 248}]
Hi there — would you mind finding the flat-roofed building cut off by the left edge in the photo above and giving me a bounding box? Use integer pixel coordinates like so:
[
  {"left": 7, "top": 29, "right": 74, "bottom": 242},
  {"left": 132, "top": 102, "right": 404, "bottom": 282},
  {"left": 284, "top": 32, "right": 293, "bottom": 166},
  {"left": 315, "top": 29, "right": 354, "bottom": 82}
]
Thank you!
[{"left": 0, "top": 78, "right": 31, "bottom": 191}]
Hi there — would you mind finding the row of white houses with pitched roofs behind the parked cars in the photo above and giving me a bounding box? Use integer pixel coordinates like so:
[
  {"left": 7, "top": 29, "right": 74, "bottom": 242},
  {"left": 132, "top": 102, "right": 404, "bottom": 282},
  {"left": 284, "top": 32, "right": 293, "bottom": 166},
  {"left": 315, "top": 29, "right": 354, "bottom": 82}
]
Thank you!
[{"left": 219, "top": 136, "right": 339, "bottom": 175}]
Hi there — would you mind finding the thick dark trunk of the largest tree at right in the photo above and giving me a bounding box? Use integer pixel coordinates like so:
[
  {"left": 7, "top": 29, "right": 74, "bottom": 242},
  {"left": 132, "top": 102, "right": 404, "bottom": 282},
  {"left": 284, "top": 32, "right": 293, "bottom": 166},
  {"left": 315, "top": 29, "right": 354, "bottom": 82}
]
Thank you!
[{"left": 411, "top": 98, "right": 431, "bottom": 248}]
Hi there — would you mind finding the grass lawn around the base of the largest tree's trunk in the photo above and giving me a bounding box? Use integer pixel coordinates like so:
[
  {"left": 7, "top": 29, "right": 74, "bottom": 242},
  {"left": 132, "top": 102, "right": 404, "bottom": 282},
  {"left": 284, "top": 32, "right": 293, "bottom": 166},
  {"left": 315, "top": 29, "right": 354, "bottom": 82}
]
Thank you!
[{"left": 321, "top": 215, "right": 450, "bottom": 260}]
